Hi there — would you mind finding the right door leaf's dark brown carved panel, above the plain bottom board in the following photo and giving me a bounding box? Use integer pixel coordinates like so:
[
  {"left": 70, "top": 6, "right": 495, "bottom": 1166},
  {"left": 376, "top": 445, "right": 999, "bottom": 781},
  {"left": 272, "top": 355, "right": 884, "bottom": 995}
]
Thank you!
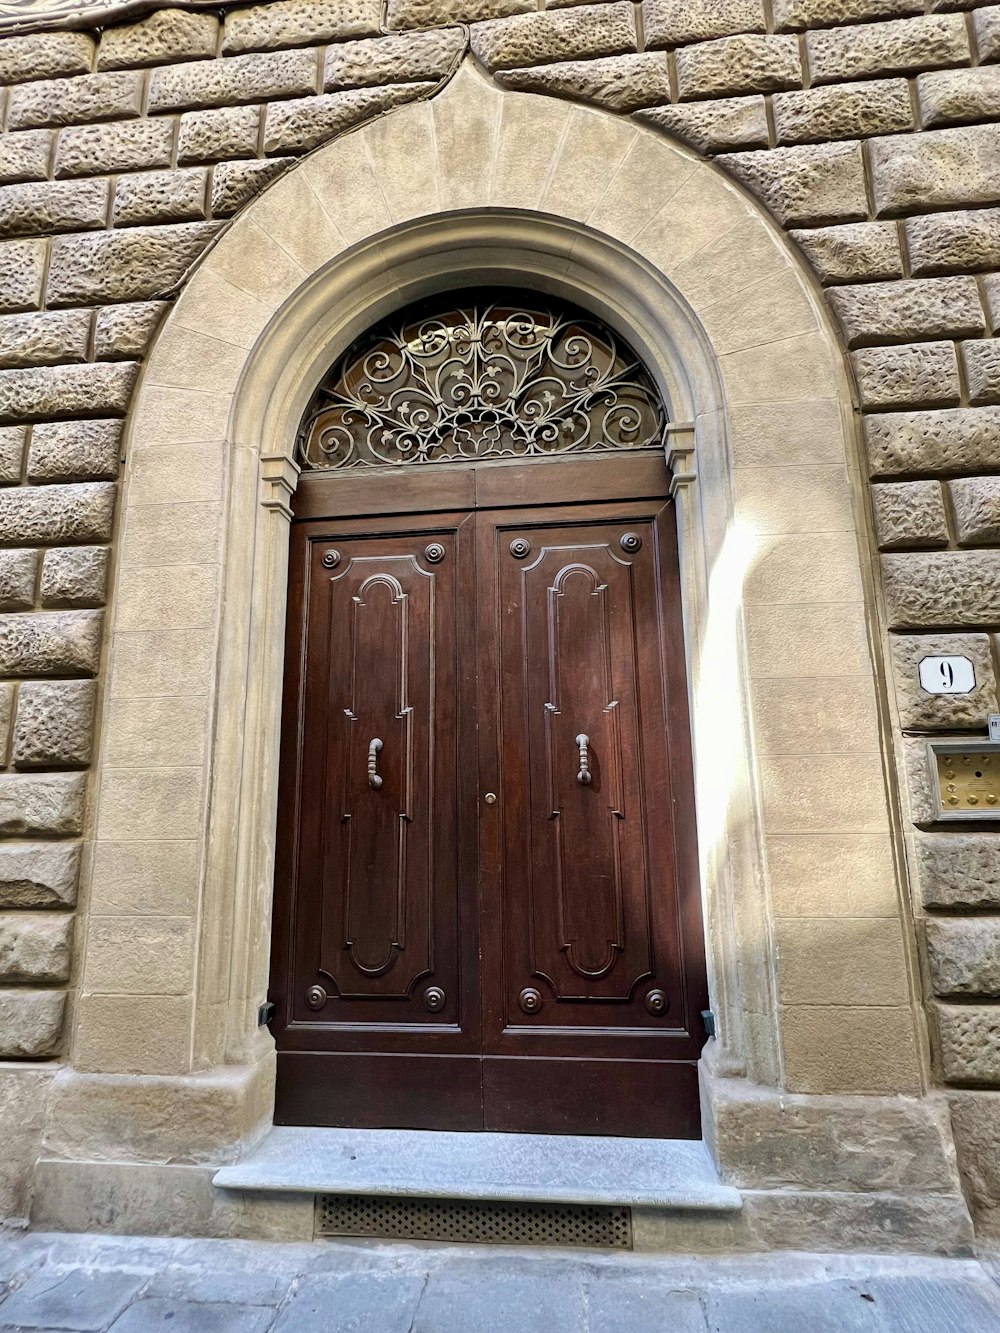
[{"left": 480, "top": 503, "right": 705, "bottom": 1060}]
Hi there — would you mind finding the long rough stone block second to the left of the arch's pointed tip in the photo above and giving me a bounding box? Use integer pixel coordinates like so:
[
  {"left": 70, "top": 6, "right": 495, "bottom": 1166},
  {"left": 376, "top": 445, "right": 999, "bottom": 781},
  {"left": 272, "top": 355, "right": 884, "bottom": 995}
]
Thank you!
[{"left": 149, "top": 51, "right": 317, "bottom": 111}]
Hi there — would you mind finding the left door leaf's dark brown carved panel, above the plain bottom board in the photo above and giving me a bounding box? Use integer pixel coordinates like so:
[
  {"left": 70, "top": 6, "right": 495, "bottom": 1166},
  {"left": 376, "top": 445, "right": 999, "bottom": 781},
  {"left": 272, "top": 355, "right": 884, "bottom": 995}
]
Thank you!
[{"left": 276, "top": 515, "right": 479, "bottom": 1053}]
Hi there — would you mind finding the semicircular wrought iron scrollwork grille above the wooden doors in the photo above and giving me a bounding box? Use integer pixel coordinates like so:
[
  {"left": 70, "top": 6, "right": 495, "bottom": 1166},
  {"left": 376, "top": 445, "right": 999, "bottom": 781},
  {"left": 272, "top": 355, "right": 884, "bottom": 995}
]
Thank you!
[{"left": 299, "top": 292, "right": 667, "bottom": 468}]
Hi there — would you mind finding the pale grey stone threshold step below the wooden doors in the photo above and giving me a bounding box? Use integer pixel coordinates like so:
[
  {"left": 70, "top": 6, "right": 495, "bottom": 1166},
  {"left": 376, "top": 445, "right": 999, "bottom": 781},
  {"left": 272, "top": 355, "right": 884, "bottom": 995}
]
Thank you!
[{"left": 213, "top": 1125, "right": 741, "bottom": 1213}]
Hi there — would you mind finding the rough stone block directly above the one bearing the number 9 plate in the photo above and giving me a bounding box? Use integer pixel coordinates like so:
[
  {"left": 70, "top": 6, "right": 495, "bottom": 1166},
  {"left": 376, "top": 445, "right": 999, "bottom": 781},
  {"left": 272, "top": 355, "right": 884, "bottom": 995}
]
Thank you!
[{"left": 881, "top": 551, "right": 1000, "bottom": 629}]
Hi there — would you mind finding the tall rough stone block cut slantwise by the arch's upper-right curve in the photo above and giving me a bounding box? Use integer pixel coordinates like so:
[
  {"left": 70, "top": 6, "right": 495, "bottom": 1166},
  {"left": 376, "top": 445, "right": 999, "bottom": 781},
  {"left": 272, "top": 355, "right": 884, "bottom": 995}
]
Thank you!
[{"left": 719, "top": 143, "right": 868, "bottom": 225}]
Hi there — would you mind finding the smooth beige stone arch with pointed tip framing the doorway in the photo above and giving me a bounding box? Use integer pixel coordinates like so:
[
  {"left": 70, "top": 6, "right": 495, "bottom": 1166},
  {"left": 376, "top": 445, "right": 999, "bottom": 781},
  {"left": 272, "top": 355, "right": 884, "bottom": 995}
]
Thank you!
[{"left": 73, "top": 65, "right": 923, "bottom": 1113}]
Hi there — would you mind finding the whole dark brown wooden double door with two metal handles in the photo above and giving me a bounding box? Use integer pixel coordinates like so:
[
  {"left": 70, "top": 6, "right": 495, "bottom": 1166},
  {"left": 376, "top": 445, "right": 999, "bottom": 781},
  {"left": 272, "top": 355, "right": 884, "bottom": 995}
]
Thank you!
[{"left": 272, "top": 459, "right": 707, "bottom": 1137}]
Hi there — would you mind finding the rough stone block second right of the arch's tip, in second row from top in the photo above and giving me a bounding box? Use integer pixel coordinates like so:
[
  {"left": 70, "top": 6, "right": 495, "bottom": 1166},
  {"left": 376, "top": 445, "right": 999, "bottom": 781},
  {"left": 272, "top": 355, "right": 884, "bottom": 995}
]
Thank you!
[{"left": 676, "top": 33, "right": 803, "bottom": 101}]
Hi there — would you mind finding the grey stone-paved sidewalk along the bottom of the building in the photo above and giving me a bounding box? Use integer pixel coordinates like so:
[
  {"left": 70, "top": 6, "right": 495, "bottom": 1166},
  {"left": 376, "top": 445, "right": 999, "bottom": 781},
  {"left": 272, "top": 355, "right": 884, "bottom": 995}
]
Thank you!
[{"left": 0, "top": 1234, "right": 1000, "bottom": 1333}]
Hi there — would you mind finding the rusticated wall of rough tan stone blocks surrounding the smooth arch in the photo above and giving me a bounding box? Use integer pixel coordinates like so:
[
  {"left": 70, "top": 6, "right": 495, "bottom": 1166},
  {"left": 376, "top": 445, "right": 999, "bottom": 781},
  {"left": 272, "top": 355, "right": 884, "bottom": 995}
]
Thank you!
[{"left": 0, "top": 0, "right": 1000, "bottom": 1206}]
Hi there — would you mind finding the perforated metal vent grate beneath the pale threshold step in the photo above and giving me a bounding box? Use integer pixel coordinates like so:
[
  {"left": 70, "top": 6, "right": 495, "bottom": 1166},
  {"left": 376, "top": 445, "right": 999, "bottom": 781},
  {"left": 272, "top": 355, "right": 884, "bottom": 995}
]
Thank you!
[{"left": 316, "top": 1194, "right": 632, "bottom": 1249}]
